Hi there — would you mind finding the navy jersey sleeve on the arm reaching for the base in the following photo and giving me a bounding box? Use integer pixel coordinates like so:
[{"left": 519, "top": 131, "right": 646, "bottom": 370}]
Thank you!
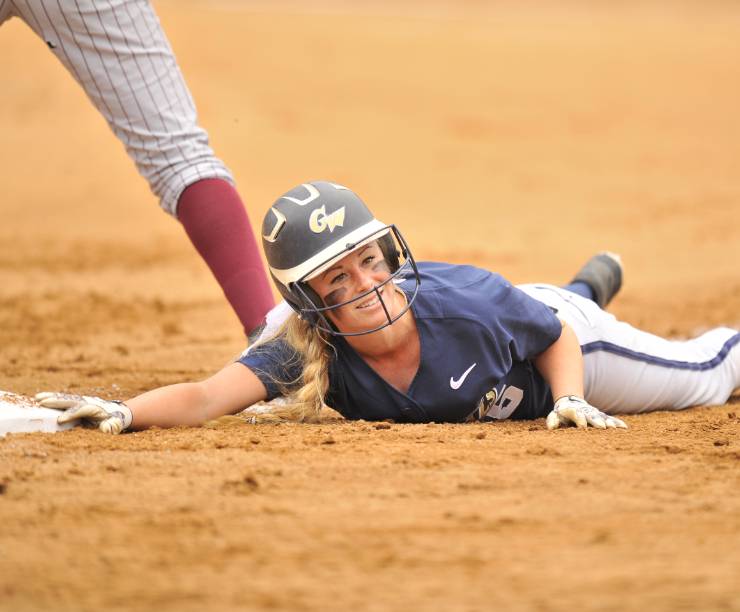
[{"left": 237, "top": 340, "right": 303, "bottom": 401}]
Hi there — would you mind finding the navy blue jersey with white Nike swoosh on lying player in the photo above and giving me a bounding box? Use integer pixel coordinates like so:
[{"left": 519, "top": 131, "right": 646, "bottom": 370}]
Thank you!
[{"left": 239, "top": 262, "right": 562, "bottom": 423}]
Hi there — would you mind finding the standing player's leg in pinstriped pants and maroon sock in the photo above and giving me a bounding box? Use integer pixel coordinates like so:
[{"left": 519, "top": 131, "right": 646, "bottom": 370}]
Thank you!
[{"left": 0, "top": 0, "right": 274, "bottom": 333}]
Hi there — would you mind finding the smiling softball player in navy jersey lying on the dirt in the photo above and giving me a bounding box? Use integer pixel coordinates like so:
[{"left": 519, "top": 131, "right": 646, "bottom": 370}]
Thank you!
[{"left": 38, "top": 182, "right": 740, "bottom": 433}]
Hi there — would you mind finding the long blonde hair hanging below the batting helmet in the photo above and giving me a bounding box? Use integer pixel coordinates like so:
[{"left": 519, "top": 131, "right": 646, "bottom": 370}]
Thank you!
[{"left": 245, "top": 313, "right": 334, "bottom": 423}]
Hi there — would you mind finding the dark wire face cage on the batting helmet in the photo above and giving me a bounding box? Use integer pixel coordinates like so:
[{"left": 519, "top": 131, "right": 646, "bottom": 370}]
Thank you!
[{"left": 291, "top": 225, "right": 421, "bottom": 336}]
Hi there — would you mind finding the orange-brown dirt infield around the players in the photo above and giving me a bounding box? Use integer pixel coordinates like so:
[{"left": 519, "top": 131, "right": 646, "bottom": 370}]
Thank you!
[{"left": 0, "top": 0, "right": 740, "bottom": 611}]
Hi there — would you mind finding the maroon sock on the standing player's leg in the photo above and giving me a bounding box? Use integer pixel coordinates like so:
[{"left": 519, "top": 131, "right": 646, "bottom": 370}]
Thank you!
[{"left": 177, "top": 179, "right": 275, "bottom": 335}]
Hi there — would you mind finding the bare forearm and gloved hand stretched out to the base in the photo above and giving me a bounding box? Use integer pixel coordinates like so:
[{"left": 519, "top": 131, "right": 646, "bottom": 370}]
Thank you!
[{"left": 36, "top": 363, "right": 267, "bottom": 434}]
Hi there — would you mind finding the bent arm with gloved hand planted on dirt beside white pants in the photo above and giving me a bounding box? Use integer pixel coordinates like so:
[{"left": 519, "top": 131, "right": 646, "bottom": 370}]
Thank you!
[{"left": 534, "top": 322, "right": 627, "bottom": 429}]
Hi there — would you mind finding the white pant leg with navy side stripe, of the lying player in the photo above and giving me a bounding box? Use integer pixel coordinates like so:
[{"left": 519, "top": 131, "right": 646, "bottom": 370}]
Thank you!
[{"left": 522, "top": 285, "right": 740, "bottom": 414}]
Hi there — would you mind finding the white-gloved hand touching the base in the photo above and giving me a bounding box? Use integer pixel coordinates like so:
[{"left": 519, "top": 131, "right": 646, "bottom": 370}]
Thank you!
[{"left": 36, "top": 391, "right": 133, "bottom": 434}]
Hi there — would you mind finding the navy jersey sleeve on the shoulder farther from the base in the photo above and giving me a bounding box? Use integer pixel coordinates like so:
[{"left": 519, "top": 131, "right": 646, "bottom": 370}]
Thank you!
[{"left": 490, "top": 277, "right": 563, "bottom": 361}]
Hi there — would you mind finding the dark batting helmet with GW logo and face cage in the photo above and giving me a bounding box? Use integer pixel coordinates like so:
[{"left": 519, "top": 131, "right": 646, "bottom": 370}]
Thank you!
[{"left": 262, "top": 181, "right": 421, "bottom": 336}]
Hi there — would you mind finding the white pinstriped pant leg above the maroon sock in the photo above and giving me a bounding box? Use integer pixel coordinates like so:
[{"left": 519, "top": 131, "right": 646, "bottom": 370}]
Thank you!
[{"left": 0, "top": 0, "right": 233, "bottom": 215}]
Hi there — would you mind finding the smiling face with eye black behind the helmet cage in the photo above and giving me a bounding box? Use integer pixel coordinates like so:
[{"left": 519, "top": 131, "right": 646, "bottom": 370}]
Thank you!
[{"left": 308, "top": 242, "right": 403, "bottom": 332}]
